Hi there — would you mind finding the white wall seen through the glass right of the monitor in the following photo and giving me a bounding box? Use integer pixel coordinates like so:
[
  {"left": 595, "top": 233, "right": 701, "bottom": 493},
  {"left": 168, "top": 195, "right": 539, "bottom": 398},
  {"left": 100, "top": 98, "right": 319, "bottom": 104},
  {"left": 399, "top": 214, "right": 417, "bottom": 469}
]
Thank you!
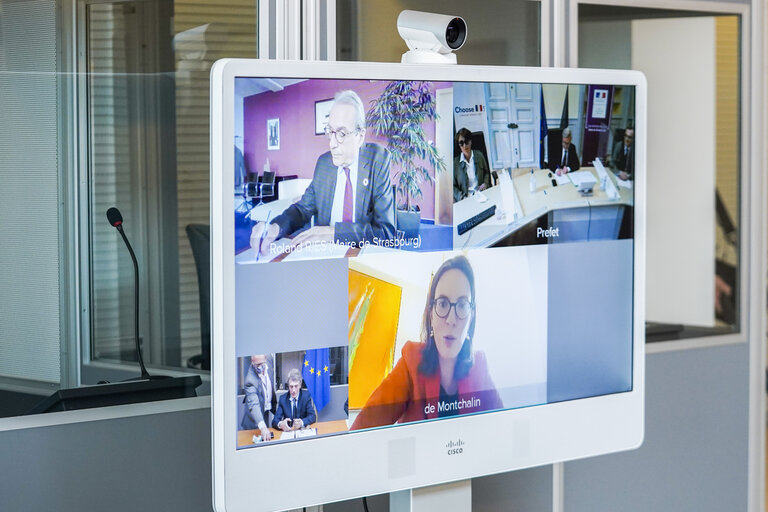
[{"left": 632, "top": 17, "right": 716, "bottom": 326}]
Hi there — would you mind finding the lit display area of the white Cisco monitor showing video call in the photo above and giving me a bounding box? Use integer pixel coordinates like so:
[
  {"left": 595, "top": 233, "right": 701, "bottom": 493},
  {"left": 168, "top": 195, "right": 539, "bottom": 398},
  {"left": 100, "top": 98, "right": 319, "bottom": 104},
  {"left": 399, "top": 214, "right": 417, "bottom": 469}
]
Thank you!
[{"left": 229, "top": 77, "right": 635, "bottom": 449}]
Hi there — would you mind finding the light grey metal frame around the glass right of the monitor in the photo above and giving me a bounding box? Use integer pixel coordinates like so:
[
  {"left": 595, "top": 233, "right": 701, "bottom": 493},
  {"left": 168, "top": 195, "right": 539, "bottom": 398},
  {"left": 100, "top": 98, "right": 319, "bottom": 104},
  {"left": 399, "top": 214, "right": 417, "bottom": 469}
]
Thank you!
[{"left": 564, "top": 4, "right": 768, "bottom": 510}]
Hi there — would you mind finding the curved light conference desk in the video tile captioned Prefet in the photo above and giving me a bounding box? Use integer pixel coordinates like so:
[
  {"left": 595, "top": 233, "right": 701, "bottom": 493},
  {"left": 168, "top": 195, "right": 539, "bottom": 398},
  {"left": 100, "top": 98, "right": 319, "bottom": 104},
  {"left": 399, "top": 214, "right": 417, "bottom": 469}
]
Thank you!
[{"left": 453, "top": 167, "right": 633, "bottom": 249}]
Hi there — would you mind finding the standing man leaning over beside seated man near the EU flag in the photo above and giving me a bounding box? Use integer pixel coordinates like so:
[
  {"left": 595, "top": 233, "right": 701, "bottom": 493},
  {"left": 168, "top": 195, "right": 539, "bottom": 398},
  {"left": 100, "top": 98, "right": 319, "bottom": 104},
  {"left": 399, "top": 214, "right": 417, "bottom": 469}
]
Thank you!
[{"left": 240, "top": 354, "right": 277, "bottom": 441}]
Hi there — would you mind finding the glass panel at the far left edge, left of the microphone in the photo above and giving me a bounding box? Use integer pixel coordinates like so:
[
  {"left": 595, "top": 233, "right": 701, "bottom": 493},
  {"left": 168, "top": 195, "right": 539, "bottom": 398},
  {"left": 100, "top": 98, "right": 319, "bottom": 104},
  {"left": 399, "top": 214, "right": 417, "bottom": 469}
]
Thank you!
[{"left": 0, "top": 0, "right": 67, "bottom": 418}]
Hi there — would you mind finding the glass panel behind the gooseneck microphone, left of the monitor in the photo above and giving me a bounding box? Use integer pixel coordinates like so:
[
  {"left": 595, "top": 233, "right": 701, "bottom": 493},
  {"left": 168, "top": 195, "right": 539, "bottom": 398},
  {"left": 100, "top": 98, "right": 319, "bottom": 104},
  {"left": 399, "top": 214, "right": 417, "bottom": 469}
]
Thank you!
[{"left": 83, "top": 0, "right": 258, "bottom": 376}]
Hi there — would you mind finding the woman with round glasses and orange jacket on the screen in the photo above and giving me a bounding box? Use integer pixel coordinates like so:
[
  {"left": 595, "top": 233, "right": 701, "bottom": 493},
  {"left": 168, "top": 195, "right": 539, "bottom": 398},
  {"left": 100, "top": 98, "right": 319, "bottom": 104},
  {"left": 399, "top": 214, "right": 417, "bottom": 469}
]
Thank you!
[{"left": 351, "top": 256, "right": 503, "bottom": 430}]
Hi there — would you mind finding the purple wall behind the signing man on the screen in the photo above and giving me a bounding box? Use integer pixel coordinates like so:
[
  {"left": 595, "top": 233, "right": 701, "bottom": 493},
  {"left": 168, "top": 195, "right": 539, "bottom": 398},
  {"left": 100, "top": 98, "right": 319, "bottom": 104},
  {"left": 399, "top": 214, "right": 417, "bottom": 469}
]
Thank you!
[{"left": 243, "top": 80, "right": 451, "bottom": 219}]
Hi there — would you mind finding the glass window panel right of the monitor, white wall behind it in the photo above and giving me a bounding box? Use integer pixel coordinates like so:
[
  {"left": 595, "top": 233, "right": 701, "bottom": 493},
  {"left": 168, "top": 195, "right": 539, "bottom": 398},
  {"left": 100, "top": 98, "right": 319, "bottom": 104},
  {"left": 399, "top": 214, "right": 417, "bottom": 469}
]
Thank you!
[{"left": 578, "top": 5, "right": 742, "bottom": 342}]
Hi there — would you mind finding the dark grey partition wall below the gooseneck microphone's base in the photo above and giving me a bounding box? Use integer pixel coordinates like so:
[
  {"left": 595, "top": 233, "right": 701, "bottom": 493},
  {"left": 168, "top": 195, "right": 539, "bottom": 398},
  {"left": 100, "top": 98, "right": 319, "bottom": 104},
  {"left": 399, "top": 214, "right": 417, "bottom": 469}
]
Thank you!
[{"left": 0, "top": 407, "right": 212, "bottom": 512}]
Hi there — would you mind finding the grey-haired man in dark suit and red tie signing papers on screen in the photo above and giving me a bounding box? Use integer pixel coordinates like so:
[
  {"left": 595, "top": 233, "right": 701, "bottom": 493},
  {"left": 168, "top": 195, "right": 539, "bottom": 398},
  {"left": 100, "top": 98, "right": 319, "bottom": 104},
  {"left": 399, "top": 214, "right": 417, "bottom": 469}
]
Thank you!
[{"left": 251, "top": 90, "right": 395, "bottom": 254}]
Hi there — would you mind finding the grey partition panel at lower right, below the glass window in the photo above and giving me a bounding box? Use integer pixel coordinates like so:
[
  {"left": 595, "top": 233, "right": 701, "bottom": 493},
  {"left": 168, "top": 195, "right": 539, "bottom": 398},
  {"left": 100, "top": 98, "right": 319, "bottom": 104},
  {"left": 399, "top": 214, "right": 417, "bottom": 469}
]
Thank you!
[{"left": 564, "top": 344, "right": 752, "bottom": 512}]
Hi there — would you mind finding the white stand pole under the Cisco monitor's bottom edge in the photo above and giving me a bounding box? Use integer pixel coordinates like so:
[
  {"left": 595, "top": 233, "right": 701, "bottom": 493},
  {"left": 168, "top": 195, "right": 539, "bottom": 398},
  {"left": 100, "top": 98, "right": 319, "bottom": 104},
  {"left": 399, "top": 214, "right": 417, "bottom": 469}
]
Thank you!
[{"left": 389, "top": 480, "right": 472, "bottom": 512}]
